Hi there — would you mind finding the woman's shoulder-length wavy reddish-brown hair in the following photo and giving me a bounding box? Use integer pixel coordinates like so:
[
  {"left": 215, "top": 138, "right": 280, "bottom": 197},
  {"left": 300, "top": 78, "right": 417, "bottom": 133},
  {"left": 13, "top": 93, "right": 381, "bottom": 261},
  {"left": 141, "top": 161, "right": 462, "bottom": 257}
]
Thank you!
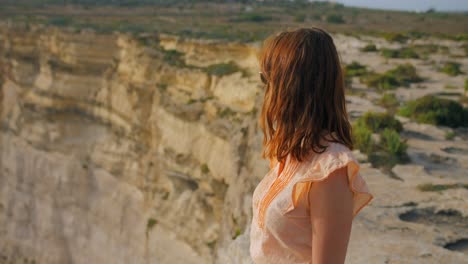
[{"left": 258, "top": 27, "right": 353, "bottom": 162}]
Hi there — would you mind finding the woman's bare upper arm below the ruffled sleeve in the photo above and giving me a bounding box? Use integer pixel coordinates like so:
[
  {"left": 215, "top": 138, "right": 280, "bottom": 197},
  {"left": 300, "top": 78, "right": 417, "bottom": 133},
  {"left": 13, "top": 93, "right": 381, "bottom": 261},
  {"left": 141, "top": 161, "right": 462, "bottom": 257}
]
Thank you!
[{"left": 308, "top": 167, "right": 353, "bottom": 264}]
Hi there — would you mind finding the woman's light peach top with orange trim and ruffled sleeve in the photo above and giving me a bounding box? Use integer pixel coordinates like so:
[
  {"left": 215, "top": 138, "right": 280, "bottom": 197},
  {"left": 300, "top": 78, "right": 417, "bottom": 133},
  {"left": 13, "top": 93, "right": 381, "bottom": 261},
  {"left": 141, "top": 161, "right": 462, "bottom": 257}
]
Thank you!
[{"left": 250, "top": 139, "right": 373, "bottom": 264}]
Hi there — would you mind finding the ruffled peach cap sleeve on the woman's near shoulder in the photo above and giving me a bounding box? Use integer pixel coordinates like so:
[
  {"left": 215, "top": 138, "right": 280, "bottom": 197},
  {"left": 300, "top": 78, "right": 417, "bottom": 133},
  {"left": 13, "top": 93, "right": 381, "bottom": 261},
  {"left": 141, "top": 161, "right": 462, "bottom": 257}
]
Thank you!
[{"left": 287, "top": 143, "right": 373, "bottom": 219}]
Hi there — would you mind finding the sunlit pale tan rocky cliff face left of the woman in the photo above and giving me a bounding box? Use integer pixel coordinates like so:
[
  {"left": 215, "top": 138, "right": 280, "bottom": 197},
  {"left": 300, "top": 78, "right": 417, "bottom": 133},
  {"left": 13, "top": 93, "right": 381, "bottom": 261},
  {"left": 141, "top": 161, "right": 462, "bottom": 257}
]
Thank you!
[{"left": 0, "top": 23, "right": 267, "bottom": 263}]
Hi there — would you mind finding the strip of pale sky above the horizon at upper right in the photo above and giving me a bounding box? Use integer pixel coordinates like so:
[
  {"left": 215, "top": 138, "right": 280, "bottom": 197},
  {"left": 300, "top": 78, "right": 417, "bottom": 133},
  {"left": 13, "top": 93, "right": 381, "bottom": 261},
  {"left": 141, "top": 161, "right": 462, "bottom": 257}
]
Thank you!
[{"left": 330, "top": 0, "right": 468, "bottom": 11}]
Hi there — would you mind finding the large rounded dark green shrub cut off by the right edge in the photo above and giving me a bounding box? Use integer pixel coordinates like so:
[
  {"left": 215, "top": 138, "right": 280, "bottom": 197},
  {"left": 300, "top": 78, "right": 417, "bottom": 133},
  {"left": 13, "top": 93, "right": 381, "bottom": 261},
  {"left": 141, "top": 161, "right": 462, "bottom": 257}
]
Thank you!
[{"left": 398, "top": 95, "right": 468, "bottom": 127}]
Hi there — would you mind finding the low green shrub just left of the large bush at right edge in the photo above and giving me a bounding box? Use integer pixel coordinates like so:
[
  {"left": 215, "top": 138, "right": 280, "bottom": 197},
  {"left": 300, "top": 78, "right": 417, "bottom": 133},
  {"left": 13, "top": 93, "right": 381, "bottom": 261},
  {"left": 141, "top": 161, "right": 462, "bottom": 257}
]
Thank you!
[{"left": 356, "top": 111, "right": 403, "bottom": 132}]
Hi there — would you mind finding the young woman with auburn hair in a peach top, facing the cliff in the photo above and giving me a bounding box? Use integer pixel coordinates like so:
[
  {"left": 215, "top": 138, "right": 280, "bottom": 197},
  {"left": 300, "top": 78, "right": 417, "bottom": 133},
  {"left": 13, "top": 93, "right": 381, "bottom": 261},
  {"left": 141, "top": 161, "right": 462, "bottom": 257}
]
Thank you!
[{"left": 250, "top": 27, "right": 373, "bottom": 264}]
